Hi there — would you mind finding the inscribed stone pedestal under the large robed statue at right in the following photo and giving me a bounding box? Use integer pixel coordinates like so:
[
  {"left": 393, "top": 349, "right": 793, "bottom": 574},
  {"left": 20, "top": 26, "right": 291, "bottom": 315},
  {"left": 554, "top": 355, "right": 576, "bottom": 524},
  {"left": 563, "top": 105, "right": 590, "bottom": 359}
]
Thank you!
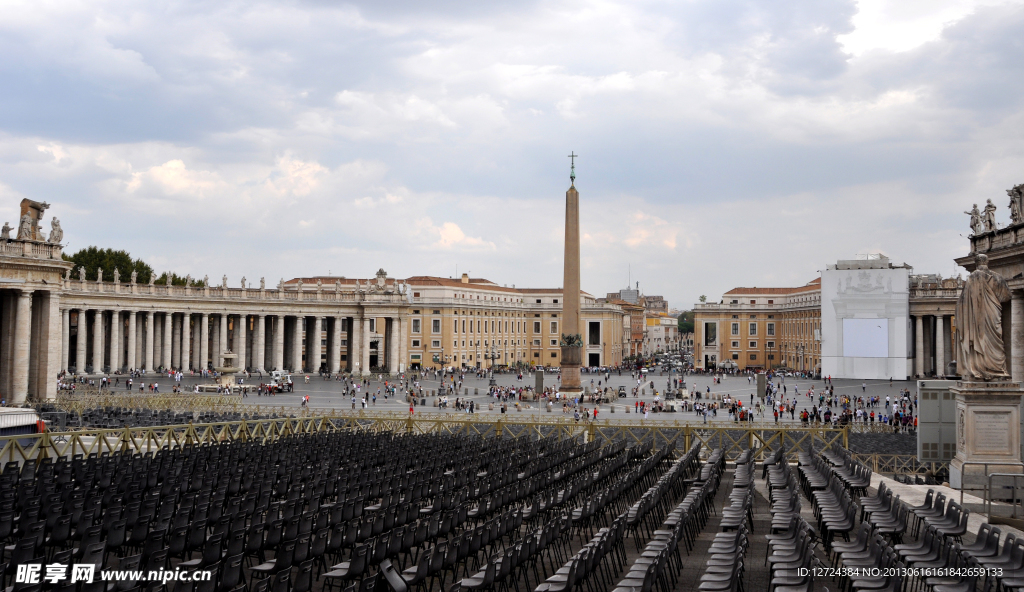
[{"left": 949, "top": 382, "right": 1024, "bottom": 497}]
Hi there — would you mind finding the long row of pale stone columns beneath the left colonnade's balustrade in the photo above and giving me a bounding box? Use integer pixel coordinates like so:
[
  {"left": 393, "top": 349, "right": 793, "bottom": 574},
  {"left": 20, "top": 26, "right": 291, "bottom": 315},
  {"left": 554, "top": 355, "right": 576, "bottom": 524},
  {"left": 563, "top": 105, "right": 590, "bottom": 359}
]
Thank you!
[{"left": 60, "top": 306, "right": 408, "bottom": 374}]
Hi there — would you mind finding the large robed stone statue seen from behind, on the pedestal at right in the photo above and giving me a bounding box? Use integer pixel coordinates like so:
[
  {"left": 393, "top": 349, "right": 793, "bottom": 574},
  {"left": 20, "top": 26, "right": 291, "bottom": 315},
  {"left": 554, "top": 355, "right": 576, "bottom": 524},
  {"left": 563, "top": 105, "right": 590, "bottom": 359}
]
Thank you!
[{"left": 955, "top": 254, "right": 1010, "bottom": 381}]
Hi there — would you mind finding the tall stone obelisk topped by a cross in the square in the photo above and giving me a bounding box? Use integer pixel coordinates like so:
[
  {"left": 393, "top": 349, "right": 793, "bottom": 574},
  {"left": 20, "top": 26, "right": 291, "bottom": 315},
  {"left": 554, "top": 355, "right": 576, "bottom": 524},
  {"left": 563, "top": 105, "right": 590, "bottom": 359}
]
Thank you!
[{"left": 559, "top": 154, "right": 583, "bottom": 395}]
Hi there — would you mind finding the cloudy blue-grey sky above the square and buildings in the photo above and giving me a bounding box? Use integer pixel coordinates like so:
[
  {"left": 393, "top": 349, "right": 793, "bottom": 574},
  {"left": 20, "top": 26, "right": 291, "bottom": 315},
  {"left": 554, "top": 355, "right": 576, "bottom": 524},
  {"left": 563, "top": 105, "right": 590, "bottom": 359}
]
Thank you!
[{"left": 0, "top": 0, "right": 1024, "bottom": 307}]
